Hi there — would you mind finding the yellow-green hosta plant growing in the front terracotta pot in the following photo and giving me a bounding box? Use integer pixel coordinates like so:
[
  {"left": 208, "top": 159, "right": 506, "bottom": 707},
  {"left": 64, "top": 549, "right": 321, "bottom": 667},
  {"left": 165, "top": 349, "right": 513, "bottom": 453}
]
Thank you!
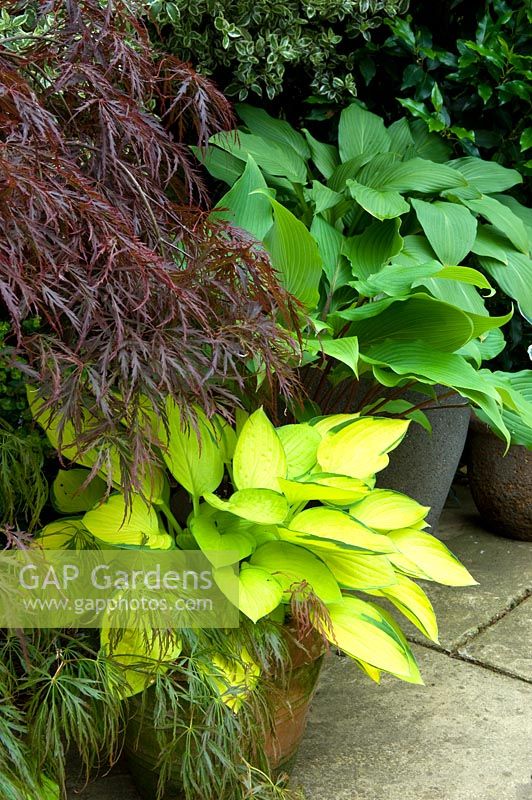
[{"left": 31, "top": 402, "right": 474, "bottom": 692}]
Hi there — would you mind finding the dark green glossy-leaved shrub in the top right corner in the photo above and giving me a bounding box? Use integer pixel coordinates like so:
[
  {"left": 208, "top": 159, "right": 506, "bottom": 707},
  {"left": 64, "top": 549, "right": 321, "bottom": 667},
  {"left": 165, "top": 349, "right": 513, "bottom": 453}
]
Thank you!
[{"left": 355, "top": 0, "right": 532, "bottom": 180}]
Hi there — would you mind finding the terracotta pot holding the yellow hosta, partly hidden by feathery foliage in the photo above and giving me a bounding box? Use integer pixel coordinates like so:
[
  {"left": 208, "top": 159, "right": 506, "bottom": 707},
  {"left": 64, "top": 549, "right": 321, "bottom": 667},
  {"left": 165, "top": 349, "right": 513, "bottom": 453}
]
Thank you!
[{"left": 124, "top": 635, "right": 324, "bottom": 800}]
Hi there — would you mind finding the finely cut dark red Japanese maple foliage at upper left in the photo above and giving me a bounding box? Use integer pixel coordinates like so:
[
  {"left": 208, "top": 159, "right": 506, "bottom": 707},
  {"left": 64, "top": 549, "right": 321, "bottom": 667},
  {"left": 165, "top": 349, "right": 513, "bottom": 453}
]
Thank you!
[{"left": 0, "top": 0, "right": 300, "bottom": 496}]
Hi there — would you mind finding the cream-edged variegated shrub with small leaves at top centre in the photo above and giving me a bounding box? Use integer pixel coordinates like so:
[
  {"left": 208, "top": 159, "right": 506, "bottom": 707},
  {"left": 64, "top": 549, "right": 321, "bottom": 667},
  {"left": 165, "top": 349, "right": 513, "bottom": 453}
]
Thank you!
[{"left": 148, "top": 0, "right": 407, "bottom": 100}]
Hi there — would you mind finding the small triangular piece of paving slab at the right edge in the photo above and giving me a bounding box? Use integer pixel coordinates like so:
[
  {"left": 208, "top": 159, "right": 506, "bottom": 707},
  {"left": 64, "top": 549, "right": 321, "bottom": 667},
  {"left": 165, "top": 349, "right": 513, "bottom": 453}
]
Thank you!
[{"left": 459, "top": 597, "right": 532, "bottom": 684}]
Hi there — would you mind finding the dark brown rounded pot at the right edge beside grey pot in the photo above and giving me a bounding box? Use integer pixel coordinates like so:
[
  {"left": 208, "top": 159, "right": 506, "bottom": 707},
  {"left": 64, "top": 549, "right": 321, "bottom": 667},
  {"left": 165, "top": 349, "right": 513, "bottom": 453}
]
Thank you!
[{"left": 467, "top": 420, "right": 532, "bottom": 542}]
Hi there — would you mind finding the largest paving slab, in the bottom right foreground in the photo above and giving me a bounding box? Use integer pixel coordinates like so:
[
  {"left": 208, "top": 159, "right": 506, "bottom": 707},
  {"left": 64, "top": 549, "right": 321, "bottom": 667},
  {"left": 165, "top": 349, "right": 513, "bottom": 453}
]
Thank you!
[{"left": 294, "top": 647, "right": 532, "bottom": 800}]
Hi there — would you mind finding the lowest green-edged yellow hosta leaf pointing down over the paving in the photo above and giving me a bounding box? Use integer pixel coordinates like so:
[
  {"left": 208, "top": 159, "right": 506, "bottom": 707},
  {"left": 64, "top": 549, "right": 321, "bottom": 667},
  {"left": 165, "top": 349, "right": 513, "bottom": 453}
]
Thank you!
[{"left": 327, "top": 597, "right": 422, "bottom": 683}]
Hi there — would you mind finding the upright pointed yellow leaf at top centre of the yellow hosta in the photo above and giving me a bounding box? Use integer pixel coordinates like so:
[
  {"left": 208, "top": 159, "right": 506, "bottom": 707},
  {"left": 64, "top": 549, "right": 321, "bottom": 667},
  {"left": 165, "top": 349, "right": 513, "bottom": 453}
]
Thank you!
[{"left": 233, "top": 408, "right": 287, "bottom": 492}]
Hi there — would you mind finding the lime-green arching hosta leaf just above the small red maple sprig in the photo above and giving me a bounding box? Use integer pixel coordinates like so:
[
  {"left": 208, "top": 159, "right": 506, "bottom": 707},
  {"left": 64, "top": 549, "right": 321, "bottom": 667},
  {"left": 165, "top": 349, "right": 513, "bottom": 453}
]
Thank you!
[{"left": 250, "top": 542, "right": 342, "bottom": 603}]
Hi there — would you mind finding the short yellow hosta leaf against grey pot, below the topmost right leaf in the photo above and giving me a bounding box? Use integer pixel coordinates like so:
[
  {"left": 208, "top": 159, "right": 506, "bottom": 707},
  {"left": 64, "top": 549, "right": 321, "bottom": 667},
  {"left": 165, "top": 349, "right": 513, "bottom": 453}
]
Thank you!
[{"left": 349, "top": 489, "right": 430, "bottom": 531}]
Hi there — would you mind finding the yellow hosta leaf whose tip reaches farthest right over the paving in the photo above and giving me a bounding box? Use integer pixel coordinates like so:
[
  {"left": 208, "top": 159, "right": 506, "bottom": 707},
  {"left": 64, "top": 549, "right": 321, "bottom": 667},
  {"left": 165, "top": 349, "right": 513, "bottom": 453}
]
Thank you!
[{"left": 388, "top": 528, "right": 476, "bottom": 586}]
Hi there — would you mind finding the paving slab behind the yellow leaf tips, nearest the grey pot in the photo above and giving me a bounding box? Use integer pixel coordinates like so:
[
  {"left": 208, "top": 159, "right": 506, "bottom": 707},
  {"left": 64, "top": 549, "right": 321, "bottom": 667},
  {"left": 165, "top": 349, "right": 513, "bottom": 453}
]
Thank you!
[{"left": 401, "top": 530, "right": 532, "bottom": 652}]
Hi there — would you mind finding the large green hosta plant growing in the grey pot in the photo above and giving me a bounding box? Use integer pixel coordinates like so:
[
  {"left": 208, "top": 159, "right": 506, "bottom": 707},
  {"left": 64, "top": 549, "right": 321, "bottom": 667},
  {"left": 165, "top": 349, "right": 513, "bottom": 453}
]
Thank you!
[{"left": 200, "top": 104, "right": 532, "bottom": 442}]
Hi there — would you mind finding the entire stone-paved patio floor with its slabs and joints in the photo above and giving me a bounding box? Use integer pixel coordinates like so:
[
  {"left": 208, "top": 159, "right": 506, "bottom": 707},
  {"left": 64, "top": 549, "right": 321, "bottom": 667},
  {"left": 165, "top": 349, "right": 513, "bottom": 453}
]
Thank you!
[{"left": 71, "top": 488, "right": 532, "bottom": 800}]
